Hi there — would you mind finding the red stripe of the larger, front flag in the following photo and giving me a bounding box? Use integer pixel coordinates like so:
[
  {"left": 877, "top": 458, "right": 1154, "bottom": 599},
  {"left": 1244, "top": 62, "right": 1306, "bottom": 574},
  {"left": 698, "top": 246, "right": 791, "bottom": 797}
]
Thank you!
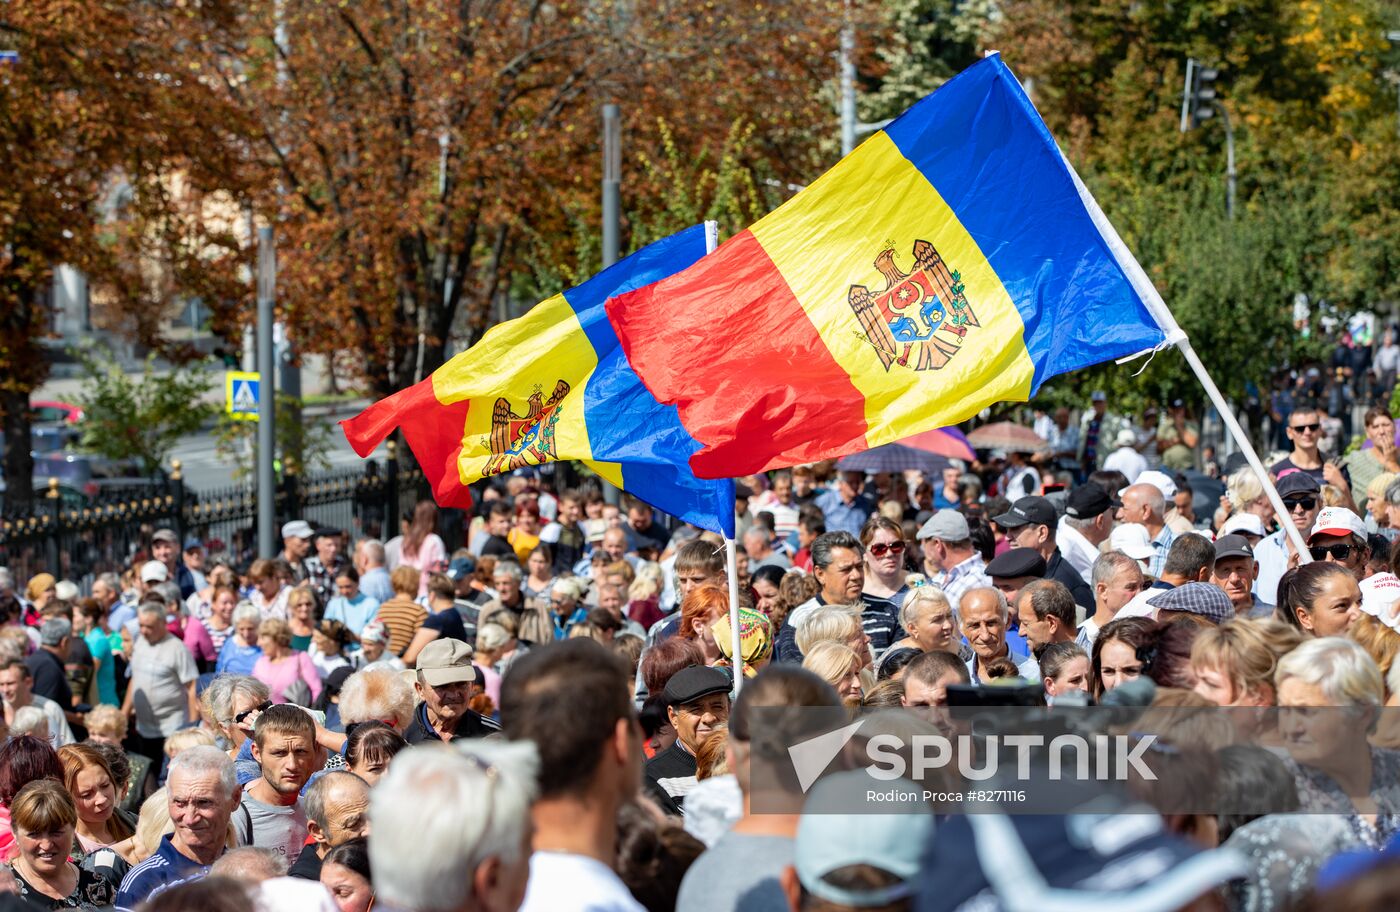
[{"left": 608, "top": 231, "right": 867, "bottom": 478}]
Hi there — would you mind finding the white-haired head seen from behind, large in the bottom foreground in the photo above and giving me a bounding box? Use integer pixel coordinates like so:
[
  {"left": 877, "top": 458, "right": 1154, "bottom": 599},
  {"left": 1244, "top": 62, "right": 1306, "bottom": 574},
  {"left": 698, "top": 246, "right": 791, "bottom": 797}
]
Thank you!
[{"left": 370, "top": 741, "right": 539, "bottom": 912}]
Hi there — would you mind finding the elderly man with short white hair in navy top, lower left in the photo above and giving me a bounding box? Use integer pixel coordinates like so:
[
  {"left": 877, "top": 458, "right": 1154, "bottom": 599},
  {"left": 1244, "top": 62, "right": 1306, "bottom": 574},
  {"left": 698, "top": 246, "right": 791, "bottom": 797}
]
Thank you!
[{"left": 116, "top": 745, "right": 242, "bottom": 912}]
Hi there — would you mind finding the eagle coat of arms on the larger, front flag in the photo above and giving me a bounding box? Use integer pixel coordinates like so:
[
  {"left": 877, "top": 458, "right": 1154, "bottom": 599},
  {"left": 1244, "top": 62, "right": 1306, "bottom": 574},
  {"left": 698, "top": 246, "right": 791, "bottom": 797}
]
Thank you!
[{"left": 847, "top": 241, "right": 980, "bottom": 371}]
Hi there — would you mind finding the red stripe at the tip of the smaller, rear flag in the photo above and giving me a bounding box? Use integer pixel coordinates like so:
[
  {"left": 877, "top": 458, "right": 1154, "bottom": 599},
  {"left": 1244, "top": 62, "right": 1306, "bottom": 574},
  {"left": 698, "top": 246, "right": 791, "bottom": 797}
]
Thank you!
[{"left": 340, "top": 377, "right": 472, "bottom": 509}]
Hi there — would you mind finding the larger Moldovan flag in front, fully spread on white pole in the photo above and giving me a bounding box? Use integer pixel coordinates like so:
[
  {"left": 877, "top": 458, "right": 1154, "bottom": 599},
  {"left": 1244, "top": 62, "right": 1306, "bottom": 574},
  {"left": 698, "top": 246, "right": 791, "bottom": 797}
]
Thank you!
[{"left": 608, "top": 55, "right": 1180, "bottom": 478}]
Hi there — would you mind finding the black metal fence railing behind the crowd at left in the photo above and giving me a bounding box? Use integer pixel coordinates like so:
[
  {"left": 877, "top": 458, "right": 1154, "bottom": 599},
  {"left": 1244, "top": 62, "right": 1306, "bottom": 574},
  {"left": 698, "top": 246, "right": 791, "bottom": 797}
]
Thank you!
[{"left": 0, "top": 444, "right": 439, "bottom": 591}]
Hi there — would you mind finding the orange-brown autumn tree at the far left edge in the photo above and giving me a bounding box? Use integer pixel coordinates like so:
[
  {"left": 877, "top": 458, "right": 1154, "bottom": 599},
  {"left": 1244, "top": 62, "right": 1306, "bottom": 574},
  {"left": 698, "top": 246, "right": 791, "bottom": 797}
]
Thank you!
[{"left": 0, "top": 0, "right": 249, "bottom": 511}]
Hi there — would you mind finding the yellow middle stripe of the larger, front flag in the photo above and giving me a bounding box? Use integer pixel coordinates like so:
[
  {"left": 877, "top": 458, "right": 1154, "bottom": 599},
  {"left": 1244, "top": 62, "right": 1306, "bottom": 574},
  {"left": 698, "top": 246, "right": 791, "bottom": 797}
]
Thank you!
[{"left": 752, "top": 133, "right": 1033, "bottom": 447}]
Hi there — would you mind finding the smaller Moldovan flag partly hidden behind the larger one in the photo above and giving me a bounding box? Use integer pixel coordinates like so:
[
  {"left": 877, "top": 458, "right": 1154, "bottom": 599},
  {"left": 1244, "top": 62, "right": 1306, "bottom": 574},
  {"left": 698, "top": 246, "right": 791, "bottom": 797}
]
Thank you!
[{"left": 342, "top": 226, "right": 734, "bottom": 538}]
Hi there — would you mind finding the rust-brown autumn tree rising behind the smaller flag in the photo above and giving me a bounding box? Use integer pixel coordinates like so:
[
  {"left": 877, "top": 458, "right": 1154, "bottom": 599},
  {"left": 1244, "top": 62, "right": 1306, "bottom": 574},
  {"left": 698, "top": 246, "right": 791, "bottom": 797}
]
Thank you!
[{"left": 162, "top": 0, "right": 840, "bottom": 395}]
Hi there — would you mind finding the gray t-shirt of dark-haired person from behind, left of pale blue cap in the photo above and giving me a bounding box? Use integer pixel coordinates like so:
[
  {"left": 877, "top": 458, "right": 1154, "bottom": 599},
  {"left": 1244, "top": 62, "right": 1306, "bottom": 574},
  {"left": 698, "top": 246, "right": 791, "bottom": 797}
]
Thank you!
[{"left": 676, "top": 832, "right": 792, "bottom": 912}]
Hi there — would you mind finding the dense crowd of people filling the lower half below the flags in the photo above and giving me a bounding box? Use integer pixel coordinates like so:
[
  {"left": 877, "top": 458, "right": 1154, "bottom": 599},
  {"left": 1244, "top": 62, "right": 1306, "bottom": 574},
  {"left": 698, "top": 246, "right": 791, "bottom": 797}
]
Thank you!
[{"left": 8, "top": 394, "right": 1400, "bottom": 912}]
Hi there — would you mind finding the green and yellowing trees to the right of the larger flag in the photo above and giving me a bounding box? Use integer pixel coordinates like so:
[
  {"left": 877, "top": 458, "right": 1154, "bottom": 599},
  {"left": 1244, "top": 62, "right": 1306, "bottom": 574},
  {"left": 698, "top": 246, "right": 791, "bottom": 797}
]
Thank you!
[{"left": 986, "top": 0, "right": 1400, "bottom": 405}]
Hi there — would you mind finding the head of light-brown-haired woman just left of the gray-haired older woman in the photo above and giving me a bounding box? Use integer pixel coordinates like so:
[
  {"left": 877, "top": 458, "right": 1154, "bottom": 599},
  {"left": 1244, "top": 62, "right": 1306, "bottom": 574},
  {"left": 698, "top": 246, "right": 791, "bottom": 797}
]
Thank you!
[{"left": 1191, "top": 618, "right": 1303, "bottom": 706}]
